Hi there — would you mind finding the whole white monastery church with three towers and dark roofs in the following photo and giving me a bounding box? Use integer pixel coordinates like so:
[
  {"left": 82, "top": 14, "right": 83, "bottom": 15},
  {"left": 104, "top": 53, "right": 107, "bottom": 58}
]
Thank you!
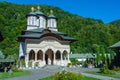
[{"left": 18, "top": 6, "right": 76, "bottom": 67}]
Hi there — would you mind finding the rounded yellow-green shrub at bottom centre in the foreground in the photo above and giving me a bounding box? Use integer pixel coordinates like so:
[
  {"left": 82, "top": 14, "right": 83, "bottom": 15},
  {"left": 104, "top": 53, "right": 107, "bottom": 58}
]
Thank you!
[{"left": 54, "top": 70, "right": 83, "bottom": 80}]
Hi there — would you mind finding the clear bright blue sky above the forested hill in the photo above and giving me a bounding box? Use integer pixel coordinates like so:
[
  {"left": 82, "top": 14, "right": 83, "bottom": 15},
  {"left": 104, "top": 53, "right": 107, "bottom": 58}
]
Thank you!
[{"left": 0, "top": 0, "right": 120, "bottom": 23}]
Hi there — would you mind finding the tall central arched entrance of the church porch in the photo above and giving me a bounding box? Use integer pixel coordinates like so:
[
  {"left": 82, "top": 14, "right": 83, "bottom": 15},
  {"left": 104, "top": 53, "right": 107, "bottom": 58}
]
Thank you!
[{"left": 45, "top": 49, "right": 54, "bottom": 65}]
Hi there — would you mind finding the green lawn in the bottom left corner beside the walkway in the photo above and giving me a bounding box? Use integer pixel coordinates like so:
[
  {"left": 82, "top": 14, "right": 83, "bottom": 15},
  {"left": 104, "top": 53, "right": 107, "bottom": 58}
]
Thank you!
[{"left": 0, "top": 70, "right": 30, "bottom": 80}]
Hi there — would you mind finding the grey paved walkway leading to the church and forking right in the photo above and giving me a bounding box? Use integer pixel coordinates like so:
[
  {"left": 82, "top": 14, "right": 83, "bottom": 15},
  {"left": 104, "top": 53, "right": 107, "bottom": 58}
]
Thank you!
[{"left": 4, "top": 66, "right": 120, "bottom": 80}]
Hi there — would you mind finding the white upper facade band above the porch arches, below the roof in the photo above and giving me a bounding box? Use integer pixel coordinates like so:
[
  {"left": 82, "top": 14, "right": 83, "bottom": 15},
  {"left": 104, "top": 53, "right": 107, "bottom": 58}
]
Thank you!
[{"left": 26, "top": 38, "right": 70, "bottom": 53}]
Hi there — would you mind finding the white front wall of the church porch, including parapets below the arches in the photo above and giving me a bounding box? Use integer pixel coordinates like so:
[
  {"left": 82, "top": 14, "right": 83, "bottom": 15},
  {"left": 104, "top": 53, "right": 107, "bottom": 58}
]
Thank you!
[{"left": 26, "top": 37, "right": 70, "bottom": 67}]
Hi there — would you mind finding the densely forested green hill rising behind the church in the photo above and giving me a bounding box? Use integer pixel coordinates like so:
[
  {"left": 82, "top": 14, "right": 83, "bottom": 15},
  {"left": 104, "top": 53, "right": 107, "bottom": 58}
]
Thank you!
[{"left": 0, "top": 2, "right": 120, "bottom": 58}]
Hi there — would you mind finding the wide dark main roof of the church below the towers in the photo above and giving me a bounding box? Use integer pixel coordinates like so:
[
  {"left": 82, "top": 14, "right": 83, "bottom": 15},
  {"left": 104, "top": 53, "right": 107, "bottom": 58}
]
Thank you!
[{"left": 18, "top": 29, "right": 77, "bottom": 41}]
